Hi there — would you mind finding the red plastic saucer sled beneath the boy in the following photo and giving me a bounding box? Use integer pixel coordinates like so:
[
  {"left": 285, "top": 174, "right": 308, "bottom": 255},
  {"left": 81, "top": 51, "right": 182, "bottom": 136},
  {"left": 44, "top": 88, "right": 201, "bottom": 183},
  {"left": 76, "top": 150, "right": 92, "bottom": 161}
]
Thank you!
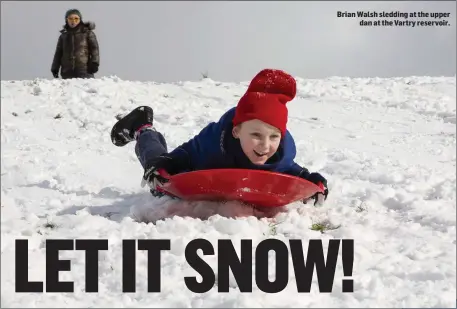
[{"left": 157, "top": 169, "right": 323, "bottom": 207}]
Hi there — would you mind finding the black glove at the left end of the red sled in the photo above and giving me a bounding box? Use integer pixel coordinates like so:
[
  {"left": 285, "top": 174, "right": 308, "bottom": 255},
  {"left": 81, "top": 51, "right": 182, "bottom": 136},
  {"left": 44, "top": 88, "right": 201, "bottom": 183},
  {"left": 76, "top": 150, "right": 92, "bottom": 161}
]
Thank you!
[{"left": 141, "top": 154, "right": 175, "bottom": 189}]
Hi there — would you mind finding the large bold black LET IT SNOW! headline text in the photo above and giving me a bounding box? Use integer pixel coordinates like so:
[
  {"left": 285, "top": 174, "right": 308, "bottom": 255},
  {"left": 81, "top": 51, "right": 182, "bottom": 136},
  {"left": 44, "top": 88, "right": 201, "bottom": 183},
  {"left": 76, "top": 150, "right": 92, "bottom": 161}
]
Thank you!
[{"left": 15, "top": 239, "right": 354, "bottom": 293}]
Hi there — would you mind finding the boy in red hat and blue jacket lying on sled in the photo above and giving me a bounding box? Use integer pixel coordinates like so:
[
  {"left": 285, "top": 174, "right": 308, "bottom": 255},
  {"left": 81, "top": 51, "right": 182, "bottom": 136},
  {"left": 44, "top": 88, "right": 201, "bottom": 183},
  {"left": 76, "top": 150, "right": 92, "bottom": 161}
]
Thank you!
[{"left": 111, "top": 69, "right": 328, "bottom": 204}]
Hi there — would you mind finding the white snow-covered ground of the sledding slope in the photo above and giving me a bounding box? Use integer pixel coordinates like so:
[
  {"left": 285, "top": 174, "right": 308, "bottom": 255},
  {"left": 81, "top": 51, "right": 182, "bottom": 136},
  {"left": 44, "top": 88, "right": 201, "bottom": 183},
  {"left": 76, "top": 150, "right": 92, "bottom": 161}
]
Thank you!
[{"left": 1, "top": 77, "right": 456, "bottom": 307}]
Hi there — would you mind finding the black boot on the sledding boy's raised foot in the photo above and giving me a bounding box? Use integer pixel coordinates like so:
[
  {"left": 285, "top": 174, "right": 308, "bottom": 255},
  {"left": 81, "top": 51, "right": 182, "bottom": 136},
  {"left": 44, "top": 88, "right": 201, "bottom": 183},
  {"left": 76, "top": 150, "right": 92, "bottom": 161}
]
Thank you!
[{"left": 111, "top": 106, "right": 154, "bottom": 147}]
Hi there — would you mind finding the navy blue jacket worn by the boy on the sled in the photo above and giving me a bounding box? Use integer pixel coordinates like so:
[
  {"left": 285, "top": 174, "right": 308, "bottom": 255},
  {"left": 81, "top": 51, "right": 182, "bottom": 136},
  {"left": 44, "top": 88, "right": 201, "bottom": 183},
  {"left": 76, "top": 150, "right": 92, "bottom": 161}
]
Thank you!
[{"left": 167, "top": 108, "right": 309, "bottom": 178}]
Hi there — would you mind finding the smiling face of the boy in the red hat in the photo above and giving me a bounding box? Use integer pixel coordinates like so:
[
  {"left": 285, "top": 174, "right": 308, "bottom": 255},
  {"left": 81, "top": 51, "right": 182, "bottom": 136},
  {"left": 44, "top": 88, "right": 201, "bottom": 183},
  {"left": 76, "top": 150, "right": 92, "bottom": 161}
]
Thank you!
[{"left": 232, "top": 119, "right": 281, "bottom": 165}]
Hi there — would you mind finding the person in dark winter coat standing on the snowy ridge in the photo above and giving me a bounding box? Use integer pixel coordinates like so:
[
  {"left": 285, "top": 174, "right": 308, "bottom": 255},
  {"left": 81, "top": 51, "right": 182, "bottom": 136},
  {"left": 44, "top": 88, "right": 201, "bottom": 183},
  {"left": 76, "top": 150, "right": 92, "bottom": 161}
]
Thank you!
[{"left": 51, "top": 9, "right": 100, "bottom": 79}]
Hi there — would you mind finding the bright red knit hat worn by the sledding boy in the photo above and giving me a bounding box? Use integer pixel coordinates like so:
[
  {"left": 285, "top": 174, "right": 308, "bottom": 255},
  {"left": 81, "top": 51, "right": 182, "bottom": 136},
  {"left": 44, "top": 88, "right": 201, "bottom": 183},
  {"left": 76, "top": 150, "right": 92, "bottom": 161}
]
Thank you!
[{"left": 233, "top": 69, "right": 297, "bottom": 136}]
